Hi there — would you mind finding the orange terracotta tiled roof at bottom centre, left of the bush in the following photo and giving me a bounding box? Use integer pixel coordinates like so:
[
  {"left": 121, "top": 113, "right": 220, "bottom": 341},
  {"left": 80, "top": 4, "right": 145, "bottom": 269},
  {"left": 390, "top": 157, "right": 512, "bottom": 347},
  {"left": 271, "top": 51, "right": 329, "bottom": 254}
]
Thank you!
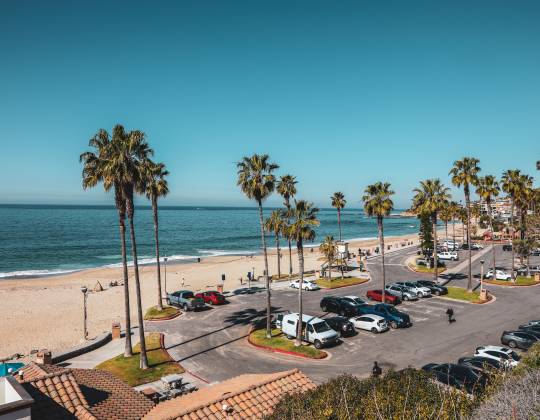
[{"left": 143, "top": 369, "right": 315, "bottom": 420}]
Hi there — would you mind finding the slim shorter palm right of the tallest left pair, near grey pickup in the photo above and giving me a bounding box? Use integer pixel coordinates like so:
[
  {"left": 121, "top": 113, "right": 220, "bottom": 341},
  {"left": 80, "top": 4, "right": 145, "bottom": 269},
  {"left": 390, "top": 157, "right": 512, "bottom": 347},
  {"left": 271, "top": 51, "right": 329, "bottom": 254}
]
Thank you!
[{"left": 144, "top": 160, "right": 169, "bottom": 311}]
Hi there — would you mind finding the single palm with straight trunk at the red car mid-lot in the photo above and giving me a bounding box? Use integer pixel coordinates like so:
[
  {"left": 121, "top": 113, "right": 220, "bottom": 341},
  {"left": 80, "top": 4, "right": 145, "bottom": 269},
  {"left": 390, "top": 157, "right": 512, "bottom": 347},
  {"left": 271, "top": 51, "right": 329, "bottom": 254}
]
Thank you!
[{"left": 362, "top": 182, "right": 394, "bottom": 302}]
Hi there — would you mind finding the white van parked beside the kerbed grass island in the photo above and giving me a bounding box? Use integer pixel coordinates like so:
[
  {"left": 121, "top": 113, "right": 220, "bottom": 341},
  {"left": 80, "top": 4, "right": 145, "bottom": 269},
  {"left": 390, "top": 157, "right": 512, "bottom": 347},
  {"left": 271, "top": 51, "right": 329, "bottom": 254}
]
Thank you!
[{"left": 278, "top": 313, "right": 339, "bottom": 349}]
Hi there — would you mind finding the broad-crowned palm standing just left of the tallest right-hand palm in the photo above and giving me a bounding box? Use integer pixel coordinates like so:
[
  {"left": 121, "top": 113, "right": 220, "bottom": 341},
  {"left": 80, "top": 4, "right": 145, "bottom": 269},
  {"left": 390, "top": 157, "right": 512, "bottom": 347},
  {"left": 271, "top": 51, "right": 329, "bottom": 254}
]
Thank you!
[{"left": 412, "top": 179, "right": 450, "bottom": 281}]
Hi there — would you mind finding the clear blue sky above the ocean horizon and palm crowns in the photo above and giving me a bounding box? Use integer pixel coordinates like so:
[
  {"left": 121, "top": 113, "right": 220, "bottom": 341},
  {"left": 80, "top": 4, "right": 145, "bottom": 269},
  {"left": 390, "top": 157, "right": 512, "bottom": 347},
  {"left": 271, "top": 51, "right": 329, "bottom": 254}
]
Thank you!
[{"left": 0, "top": 0, "right": 540, "bottom": 207}]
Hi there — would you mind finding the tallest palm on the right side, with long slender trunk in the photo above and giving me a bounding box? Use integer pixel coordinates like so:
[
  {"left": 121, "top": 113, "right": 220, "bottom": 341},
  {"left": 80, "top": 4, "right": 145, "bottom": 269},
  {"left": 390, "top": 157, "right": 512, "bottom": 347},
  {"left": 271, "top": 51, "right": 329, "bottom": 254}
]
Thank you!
[{"left": 449, "top": 157, "right": 480, "bottom": 291}]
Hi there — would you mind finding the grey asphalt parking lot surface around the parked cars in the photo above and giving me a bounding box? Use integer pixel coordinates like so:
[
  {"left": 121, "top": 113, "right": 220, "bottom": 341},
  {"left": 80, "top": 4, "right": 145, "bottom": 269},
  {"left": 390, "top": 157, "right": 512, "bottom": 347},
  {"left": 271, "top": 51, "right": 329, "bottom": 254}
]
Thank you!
[{"left": 146, "top": 246, "right": 540, "bottom": 383}]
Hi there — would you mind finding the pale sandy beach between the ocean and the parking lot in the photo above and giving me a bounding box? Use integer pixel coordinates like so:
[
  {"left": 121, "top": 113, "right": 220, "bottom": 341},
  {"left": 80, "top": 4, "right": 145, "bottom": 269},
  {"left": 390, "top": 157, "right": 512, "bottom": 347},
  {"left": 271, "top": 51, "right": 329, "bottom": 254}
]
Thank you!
[{"left": 0, "top": 226, "right": 464, "bottom": 358}]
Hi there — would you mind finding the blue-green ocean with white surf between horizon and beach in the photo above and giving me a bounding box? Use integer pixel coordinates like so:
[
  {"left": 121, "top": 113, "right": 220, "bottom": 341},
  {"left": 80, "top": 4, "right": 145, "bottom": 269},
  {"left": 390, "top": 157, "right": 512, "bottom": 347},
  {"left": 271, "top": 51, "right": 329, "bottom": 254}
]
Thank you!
[{"left": 0, "top": 205, "right": 419, "bottom": 279}]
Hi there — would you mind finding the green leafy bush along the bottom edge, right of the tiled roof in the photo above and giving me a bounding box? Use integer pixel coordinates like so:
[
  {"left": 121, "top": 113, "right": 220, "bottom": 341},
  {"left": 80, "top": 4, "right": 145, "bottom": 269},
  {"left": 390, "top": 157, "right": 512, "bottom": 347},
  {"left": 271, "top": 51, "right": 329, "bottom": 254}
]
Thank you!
[{"left": 270, "top": 369, "right": 475, "bottom": 420}]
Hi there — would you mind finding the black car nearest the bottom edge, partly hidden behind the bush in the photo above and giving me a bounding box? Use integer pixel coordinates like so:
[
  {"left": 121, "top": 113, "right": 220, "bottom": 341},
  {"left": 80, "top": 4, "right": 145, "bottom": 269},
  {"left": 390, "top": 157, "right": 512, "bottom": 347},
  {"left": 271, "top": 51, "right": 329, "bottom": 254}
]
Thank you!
[{"left": 422, "top": 363, "right": 487, "bottom": 394}]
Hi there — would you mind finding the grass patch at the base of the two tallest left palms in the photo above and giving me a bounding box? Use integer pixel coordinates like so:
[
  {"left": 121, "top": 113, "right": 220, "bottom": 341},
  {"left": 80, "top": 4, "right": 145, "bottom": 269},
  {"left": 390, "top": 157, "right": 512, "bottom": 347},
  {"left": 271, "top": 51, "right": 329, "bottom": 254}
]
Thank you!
[{"left": 96, "top": 333, "right": 184, "bottom": 386}]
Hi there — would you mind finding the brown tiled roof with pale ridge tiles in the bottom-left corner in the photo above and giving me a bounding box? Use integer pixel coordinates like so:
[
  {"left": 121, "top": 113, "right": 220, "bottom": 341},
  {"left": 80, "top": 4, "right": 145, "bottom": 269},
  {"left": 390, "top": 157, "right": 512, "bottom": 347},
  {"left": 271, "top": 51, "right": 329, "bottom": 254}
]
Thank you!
[{"left": 15, "top": 363, "right": 154, "bottom": 420}]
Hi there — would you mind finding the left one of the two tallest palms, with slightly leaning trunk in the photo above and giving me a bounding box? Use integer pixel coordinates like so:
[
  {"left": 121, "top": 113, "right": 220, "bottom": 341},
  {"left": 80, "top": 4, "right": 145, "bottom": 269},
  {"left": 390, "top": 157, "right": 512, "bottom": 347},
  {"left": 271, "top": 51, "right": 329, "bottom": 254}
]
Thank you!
[{"left": 79, "top": 127, "right": 133, "bottom": 357}]
